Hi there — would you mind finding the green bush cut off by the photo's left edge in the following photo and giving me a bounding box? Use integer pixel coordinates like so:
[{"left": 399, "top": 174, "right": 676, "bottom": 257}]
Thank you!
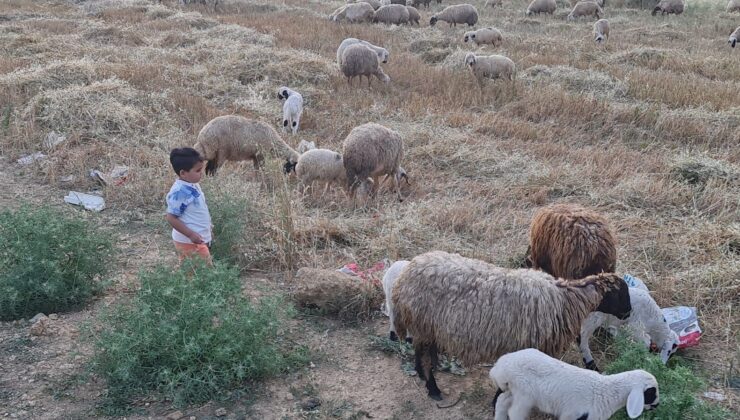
[{"left": 0, "top": 205, "right": 112, "bottom": 321}]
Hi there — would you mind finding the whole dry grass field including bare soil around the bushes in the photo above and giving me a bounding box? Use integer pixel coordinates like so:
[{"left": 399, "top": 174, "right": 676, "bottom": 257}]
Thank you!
[{"left": 0, "top": 0, "right": 740, "bottom": 419}]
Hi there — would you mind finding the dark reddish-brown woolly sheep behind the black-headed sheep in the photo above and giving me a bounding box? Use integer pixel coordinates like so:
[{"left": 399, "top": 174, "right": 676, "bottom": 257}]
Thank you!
[{"left": 529, "top": 204, "right": 617, "bottom": 279}]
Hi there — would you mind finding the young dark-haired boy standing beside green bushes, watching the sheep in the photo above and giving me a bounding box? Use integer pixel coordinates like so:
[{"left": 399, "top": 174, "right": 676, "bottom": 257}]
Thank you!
[{"left": 165, "top": 147, "right": 211, "bottom": 264}]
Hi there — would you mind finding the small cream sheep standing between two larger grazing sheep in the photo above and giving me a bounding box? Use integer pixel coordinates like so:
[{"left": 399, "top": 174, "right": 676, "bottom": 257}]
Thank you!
[{"left": 295, "top": 149, "right": 347, "bottom": 194}]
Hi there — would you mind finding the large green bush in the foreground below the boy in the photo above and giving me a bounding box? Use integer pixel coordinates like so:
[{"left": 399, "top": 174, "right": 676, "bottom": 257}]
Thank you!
[{"left": 93, "top": 259, "right": 307, "bottom": 410}]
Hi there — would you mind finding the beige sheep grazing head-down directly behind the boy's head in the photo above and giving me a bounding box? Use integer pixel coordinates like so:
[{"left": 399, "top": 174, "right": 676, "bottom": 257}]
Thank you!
[{"left": 193, "top": 115, "right": 299, "bottom": 175}]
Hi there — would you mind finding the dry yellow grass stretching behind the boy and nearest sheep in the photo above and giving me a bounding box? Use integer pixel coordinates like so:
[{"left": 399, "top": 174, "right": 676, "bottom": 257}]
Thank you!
[{"left": 0, "top": 0, "right": 740, "bottom": 418}]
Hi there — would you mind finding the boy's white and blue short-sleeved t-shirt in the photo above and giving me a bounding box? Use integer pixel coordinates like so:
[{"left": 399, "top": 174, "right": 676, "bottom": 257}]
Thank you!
[{"left": 167, "top": 179, "right": 211, "bottom": 244}]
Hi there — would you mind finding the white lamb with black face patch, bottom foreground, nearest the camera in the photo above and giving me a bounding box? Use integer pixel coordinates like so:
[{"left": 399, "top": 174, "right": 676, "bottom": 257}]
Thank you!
[{"left": 489, "top": 349, "right": 660, "bottom": 420}]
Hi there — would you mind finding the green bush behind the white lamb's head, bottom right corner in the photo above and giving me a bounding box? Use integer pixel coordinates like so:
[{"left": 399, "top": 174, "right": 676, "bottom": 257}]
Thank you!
[{"left": 605, "top": 334, "right": 730, "bottom": 420}]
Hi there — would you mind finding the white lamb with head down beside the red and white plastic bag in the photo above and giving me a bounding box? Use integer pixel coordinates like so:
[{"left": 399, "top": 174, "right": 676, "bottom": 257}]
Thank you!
[{"left": 578, "top": 287, "right": 679, "bottom": 371}]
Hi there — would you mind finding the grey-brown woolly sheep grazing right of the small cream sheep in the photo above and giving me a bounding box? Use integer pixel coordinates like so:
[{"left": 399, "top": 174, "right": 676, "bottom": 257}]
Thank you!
[{"left": 342, "top": 123, "right": 403, "bottom": 201}]
